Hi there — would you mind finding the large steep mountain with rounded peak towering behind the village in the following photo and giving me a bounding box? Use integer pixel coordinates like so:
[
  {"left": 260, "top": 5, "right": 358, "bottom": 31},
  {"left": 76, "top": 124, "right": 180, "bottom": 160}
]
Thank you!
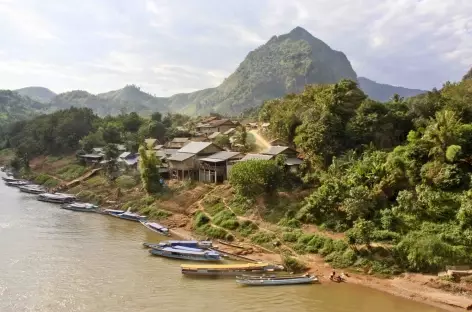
[{"left": 164, "top": 27, "right": 357, "bottom": 115}]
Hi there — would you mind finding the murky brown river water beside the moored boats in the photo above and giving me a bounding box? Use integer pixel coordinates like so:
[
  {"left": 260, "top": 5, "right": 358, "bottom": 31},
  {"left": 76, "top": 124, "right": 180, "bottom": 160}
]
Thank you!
[{"left": 0, "top": 178, "right": 441, "bottom": 312}]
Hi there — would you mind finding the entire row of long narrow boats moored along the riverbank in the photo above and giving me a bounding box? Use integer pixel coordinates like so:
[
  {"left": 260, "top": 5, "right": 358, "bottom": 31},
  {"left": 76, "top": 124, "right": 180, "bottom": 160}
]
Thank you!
[{"left": 3, "top": 173, "right": 318, "bottom": 286}]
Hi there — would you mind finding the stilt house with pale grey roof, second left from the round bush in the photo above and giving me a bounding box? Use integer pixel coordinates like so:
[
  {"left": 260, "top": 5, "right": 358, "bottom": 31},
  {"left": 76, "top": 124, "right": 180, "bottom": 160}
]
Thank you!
[{"left": 167, "top": 142, "right": 223, "bottom": 180}]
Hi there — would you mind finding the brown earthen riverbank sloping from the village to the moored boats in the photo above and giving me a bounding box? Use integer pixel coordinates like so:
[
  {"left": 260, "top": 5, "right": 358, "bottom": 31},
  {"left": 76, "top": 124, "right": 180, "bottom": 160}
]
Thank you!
[{"left": 1, "top": 158, "right": 472, "bottom": 311}]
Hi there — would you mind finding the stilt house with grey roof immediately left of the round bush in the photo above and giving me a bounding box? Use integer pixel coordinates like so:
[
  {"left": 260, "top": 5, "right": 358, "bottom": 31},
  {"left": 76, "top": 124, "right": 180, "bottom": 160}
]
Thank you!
[{"left": 198, "top": 151, "right": 243, "bottom": 183}]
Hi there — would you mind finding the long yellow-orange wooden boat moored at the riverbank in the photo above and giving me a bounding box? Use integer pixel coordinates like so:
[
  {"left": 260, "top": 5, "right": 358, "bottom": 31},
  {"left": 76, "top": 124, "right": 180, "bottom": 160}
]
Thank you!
[{"left": 180, "top": 262, "right": 283, "bottom": 276}]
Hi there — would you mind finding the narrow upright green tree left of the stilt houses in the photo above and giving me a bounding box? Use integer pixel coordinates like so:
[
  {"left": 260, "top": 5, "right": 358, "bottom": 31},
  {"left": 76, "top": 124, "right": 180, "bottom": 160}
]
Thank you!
[{"left": 139, "top": 146, "right": 162, "bottom": 194}]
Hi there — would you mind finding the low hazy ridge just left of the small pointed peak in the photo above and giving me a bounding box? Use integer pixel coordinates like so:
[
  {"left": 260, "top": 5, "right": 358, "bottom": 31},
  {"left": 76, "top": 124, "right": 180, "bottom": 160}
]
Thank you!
[{"left": 49, "top": 90, "right": 148, "bottom": 116}]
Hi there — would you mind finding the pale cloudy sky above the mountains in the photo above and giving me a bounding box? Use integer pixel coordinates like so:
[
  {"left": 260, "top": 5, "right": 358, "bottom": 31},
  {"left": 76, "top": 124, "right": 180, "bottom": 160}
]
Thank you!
[{"left": 0, "top": 0, "right": 472, "bottom": 96}]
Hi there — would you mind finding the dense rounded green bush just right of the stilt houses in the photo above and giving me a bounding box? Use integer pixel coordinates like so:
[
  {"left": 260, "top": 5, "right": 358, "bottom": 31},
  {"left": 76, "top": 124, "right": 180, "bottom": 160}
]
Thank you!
[{"left": 229, "top": 160, "right": 282, "bottom": 197}]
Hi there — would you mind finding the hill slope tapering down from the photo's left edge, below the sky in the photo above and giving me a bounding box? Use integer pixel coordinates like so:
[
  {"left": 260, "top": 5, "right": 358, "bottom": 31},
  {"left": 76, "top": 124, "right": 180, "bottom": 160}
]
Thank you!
[{"left": 0, "top": 90, "right": 45, "bottom": 126}]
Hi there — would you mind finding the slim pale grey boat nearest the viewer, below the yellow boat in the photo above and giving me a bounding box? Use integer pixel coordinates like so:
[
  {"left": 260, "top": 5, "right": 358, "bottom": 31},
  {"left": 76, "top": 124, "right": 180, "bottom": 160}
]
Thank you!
[{"left": 236, "top": 274, "right": 318, "bottom": 286}]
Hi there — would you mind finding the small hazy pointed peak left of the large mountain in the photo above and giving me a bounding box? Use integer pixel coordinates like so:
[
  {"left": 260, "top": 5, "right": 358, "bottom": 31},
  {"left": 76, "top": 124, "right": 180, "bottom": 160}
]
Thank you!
[{"left": 97, "top": 85, "right": 168, "bottom": 112}]
